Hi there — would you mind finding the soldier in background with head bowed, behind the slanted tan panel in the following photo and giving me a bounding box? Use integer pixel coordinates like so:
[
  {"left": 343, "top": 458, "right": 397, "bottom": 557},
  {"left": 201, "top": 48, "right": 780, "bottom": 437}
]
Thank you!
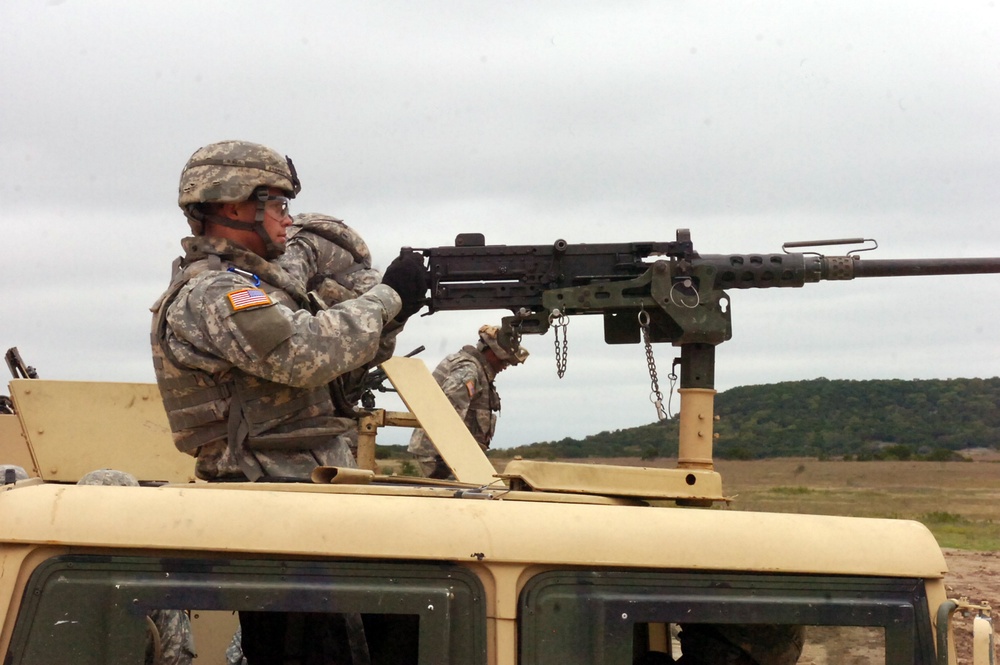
[{"left": 407, "top": 325, "right": 528, "bottom": 478}]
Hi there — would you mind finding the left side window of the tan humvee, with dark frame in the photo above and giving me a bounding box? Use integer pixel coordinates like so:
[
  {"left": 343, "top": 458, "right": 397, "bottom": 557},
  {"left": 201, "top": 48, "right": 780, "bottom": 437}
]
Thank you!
[{"left": 7, "top": 556, "right": 486, "bottom": 665}]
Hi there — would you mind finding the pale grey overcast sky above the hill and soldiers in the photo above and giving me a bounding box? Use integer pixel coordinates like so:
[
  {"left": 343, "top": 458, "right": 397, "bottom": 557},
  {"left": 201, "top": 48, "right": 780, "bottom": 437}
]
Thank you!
[{"left": 0, "top": 0, "right": 1000, "bottom": 446}]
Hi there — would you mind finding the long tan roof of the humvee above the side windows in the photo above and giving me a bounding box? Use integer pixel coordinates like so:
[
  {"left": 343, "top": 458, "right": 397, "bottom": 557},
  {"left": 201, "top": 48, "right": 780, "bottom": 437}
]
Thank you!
[{"left": 0, "top": 480, "right": 947, "bottom": 578}]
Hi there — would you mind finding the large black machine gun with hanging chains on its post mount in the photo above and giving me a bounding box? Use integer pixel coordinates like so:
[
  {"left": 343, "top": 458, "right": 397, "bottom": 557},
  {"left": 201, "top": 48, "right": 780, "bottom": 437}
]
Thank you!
[{"left": 402, "top": 229, "right": 1000, "bottom": 469}]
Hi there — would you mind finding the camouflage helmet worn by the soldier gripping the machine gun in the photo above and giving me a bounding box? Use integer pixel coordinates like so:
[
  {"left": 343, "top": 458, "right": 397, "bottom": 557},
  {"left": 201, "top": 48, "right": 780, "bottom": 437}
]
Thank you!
[{"left": 177, "top": 141, "right": 302, "bottom": 235}]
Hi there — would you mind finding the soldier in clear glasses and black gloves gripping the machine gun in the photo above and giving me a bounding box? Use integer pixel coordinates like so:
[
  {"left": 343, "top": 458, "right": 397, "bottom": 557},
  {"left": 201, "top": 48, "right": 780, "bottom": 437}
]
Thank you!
[{"left": 152, "top": 141, "right": 425, "bottom": 481}]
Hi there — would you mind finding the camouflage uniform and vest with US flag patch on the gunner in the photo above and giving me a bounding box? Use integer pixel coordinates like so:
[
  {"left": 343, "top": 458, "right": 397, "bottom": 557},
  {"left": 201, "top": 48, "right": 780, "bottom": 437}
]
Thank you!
[{"left": 153, "top": 237, "right": 400, "bottom": 480}]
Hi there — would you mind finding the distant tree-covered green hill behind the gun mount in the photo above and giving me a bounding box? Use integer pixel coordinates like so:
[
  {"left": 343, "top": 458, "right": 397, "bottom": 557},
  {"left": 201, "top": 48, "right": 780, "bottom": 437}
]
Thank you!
[{"left": 491, "top": 377, "right": 1000, "bottom": 460}]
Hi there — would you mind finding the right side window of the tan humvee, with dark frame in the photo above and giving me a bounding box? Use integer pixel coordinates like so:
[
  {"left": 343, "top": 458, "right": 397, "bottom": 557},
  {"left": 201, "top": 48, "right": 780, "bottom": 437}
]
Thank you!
[{"left": 519, "top": 571, "right": 934, "bottom": 665}]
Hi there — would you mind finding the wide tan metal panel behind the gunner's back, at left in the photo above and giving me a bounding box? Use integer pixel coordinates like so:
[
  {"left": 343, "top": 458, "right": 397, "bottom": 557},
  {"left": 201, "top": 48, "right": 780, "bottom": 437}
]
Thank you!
[{"left": 10, "top": 379, "right": 194, "bottom": 482}]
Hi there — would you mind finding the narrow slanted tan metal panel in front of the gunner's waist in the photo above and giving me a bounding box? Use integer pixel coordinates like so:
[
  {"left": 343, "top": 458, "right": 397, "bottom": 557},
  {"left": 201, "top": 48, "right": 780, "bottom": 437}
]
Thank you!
[{"left": 382, "top": 356, "right": 499, "bottom": 485}]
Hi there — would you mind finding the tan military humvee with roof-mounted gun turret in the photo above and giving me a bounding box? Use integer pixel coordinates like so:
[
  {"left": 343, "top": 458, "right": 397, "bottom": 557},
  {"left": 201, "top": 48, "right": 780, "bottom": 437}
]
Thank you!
[{"left": 0, "top": 358, "right": 992, "bottom": 665}]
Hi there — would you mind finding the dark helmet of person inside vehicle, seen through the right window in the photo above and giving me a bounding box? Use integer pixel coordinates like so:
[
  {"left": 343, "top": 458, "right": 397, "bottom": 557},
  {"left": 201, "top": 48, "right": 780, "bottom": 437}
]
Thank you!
[{"left": 680, "top": 624, "right": 805, "bottom": 665}]
